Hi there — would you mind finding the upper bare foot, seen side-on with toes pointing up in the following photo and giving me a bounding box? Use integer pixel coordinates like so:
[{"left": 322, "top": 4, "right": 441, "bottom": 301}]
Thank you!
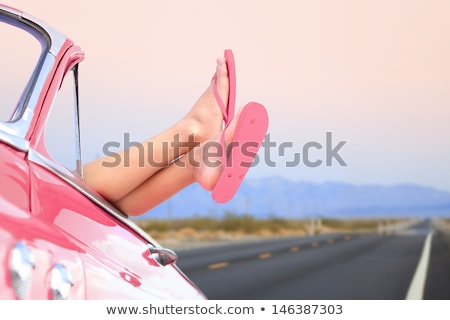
[{"left": 183, "top": 58, "right": 229, "bottom": 143}]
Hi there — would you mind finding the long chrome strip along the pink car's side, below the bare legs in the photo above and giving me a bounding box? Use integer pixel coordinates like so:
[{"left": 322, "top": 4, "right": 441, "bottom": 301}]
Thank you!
[{"left": 28, "top": 148, "right": 161, "bottom": 247}]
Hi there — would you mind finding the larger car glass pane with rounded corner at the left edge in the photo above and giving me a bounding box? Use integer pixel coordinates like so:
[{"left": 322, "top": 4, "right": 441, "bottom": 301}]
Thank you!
[{"left": 0, "top": 21, "right": 41, "bottom": 122}]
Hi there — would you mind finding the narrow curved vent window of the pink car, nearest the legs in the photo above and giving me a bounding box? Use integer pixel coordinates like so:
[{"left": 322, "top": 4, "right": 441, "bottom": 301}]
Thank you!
[{"left": 45, "top": 71, "right": 76, "bottom": 171}]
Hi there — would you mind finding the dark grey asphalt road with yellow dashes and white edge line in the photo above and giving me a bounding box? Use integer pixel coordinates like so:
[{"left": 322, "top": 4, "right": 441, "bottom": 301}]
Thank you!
[{"left": 178, "top": 221, "right": 450, "bottom": 300}]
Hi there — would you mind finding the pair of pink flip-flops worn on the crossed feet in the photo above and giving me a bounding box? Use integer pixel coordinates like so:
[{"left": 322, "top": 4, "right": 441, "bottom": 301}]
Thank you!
[{"left": 212, "top": 50, "right": 269, "bottom": 203}]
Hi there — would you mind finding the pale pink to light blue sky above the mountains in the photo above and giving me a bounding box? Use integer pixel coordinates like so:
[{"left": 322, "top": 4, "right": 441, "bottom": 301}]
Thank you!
[{"left": 3, "top": 0, "right": 450, "bottom": 192}]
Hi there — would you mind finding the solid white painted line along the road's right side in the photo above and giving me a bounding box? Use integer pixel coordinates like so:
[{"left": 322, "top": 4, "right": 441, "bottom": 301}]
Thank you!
[{"left": 406, "top": 231, "right": 433, "bottom": 300}]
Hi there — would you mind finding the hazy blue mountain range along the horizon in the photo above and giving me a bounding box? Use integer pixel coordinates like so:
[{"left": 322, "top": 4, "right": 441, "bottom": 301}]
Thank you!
[{"left": 134, "top": 177, "right": 450, "bottom": 219}]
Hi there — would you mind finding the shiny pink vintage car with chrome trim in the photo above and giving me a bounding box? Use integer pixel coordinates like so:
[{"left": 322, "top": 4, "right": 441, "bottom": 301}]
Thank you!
[{"left": 0, "top": 5, "right": 205, "bottom": 299}]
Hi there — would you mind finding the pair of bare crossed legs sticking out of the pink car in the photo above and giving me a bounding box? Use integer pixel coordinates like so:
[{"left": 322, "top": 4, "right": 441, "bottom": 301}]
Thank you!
[{"left": 83, "top": 58, "right": 237, "bottom": 215}]
